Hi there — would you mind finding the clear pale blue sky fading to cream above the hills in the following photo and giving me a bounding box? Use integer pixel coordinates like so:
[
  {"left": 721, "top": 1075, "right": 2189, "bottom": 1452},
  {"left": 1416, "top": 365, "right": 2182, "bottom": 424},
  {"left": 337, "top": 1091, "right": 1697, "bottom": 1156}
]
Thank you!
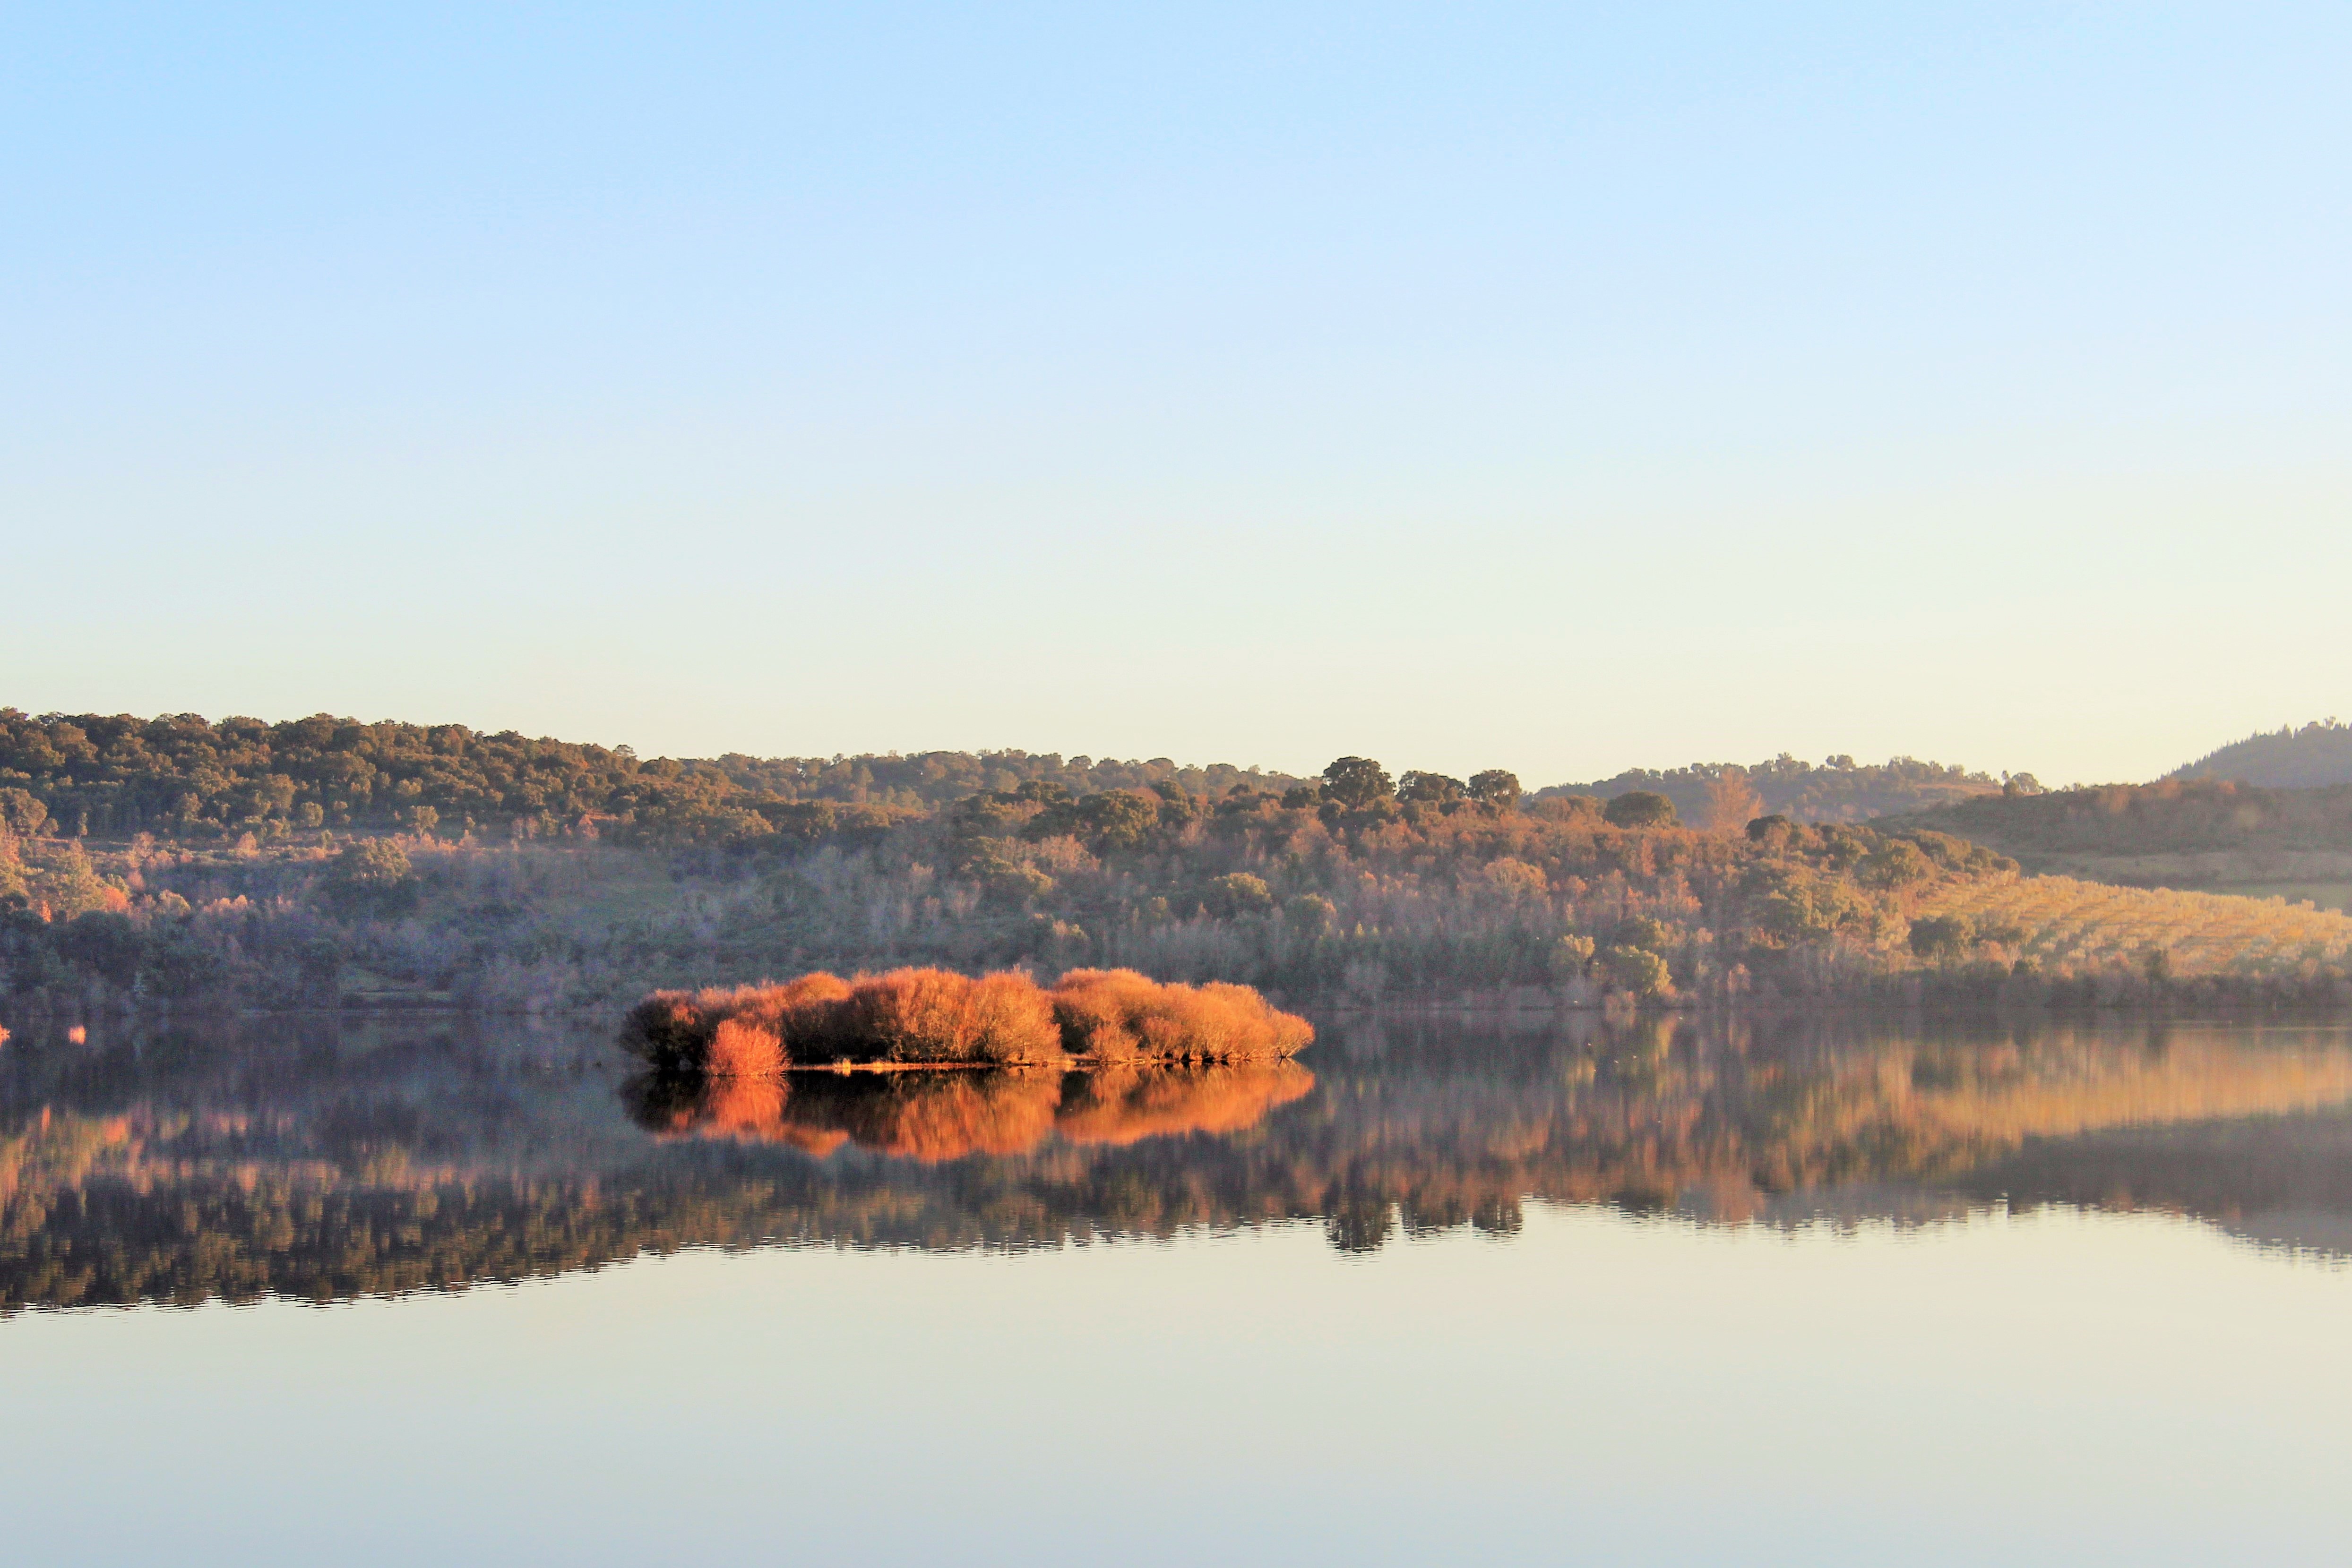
[{"left": 0, "top": 2, "right": 2352, "bottom": 783}]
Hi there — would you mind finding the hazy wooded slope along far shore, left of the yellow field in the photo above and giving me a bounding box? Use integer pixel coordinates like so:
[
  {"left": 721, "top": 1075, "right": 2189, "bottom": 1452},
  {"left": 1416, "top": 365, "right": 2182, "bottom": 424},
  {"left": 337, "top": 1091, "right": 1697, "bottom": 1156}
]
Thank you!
[{"left": 0, "top": 757, "right": 2050, "bottom": 1009}]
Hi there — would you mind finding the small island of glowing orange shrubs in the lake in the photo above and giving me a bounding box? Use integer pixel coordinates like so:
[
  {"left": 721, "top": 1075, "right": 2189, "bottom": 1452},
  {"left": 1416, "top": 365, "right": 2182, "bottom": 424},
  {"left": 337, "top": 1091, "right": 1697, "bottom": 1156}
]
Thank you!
[{"left": 621, "top": 968, "right": 1315, "bottom": 1077}]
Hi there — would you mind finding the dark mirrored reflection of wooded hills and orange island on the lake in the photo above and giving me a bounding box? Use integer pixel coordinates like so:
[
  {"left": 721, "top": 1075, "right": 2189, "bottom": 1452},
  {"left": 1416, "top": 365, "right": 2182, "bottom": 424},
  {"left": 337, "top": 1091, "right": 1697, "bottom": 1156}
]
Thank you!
[{"left": 0, "top": 1018, "right": 2352, "bottom": 1310}]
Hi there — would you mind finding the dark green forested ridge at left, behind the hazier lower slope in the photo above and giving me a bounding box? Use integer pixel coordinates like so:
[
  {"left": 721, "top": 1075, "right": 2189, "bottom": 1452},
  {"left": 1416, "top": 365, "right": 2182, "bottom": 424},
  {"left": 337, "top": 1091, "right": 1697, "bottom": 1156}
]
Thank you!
[{"left": 0, "top": 708, "right": 1298, "bottom": 841}]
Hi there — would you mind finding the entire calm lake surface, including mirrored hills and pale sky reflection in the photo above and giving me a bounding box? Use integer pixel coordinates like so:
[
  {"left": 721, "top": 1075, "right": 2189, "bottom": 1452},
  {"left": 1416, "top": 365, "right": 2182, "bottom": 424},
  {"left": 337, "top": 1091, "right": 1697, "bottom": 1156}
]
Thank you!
[{"left": 0, "top": 1020, "right": 2352, "bottom": 1566}]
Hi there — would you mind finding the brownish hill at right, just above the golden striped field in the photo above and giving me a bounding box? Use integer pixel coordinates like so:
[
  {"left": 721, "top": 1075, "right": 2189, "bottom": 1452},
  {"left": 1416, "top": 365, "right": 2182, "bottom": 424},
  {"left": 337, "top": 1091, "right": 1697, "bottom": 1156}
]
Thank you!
[{"left": 1875, "top": 780, "right": 2352, "bottom": 910}]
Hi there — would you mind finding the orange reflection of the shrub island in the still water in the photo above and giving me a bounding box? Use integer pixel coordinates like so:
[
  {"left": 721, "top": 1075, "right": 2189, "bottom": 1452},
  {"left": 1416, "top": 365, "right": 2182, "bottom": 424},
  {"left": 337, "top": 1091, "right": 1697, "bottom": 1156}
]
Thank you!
[{"left": 623, "top": 1062, "right": 1315, "bottom": 1164}]
